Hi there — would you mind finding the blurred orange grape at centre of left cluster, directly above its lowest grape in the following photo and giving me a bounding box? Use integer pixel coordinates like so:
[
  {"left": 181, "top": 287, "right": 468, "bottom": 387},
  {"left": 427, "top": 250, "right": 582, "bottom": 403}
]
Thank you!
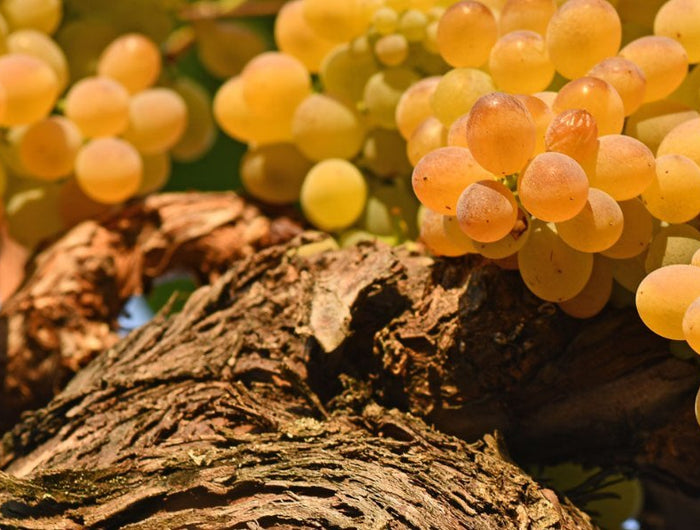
[{"left": 65, "top": 77, "right": 129, "bottom": 138}]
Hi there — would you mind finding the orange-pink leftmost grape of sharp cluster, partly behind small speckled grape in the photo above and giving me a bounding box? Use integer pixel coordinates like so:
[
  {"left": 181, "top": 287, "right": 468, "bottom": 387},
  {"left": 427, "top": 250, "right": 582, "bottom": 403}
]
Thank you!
[{"left": 412, "top": 147, "right": 494, "bottom": 215}]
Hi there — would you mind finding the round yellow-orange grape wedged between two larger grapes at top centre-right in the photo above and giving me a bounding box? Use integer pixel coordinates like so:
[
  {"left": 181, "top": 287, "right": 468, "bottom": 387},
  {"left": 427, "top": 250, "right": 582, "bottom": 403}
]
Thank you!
[{"left": 489, "top": 30, "right": 554, "bottom": 94}]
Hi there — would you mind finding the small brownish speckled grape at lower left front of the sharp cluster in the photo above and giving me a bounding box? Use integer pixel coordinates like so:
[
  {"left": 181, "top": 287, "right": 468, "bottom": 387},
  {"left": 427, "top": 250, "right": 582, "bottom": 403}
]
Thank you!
[{"left": 457, "top": 180, "right": 518, "bottom": 243}]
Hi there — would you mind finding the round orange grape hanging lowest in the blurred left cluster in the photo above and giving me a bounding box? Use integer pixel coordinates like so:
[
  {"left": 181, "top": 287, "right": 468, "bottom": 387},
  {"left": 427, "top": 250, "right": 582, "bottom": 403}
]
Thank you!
[{"left": 75, "top": 137, "right": 143, "bottom": 204}]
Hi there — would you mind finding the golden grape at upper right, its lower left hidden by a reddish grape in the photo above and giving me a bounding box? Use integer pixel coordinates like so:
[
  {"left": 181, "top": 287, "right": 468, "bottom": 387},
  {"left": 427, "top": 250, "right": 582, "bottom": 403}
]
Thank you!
[{"left": 620, "top": 35, "right": 688, "bottom": 103}]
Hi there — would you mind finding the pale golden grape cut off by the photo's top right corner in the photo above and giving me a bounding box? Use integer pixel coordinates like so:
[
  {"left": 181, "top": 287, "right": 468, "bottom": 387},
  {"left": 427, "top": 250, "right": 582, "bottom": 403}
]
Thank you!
[{"left": 654, "top": 0, "right": 700, "bottom": 64}]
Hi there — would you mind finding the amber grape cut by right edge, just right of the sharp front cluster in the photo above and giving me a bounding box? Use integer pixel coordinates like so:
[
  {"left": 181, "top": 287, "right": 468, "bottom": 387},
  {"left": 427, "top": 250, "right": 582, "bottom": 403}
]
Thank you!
[{"left": 642, "top": 154, "right": 700, "bottom": 223}]
